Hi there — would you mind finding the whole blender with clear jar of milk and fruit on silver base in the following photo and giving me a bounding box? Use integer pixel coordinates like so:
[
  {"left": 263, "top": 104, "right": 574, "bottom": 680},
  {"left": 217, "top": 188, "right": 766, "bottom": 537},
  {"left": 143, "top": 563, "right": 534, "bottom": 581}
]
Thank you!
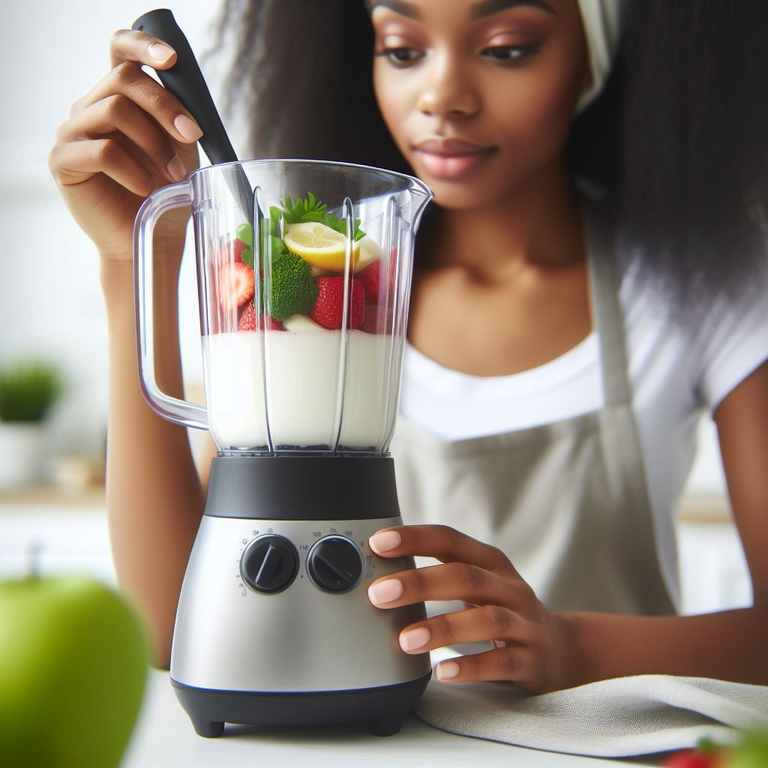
[{"left": 135, "top": 153, "right": 432, "bottom": 736}]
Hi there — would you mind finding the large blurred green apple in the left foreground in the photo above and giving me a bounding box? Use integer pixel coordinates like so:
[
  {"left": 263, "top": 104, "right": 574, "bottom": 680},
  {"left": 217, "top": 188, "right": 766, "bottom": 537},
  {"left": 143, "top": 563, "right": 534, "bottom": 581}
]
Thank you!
[{"left": 0, "top": 576, "right": 149, "bottom": 768}]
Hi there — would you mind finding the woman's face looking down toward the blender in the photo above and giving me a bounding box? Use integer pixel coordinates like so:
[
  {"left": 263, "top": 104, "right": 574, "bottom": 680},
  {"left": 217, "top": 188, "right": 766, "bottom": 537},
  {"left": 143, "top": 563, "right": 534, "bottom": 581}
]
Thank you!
[{"left": 371, "top": 0, "right": 589, "bottom": 209}]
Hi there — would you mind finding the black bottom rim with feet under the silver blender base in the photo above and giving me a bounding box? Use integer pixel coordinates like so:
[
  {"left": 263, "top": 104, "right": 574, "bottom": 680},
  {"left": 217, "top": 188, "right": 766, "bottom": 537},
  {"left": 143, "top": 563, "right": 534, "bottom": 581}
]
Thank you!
[{"left": 171, "top": 671, "right": 432, "bottom": 738}]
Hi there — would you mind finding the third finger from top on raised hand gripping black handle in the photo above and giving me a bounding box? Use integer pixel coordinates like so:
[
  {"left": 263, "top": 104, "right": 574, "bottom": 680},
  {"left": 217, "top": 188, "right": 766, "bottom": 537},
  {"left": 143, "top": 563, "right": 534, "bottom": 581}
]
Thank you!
[{"left": 57, "top": 94, "right": 186, "bottom": 181}]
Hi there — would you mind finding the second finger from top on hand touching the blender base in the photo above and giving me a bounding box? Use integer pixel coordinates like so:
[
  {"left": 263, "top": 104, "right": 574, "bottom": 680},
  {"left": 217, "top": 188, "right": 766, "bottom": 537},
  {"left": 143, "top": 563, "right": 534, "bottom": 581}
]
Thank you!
[{"left": 368, "top": 563, "right": 535, "bottom": 612}]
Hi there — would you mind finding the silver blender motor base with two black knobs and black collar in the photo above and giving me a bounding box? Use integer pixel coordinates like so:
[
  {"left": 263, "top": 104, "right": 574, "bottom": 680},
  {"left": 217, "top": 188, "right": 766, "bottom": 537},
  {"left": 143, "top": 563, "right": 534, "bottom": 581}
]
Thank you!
[{"left": 170, "top": 456, "right": 432, "bottom": 738}]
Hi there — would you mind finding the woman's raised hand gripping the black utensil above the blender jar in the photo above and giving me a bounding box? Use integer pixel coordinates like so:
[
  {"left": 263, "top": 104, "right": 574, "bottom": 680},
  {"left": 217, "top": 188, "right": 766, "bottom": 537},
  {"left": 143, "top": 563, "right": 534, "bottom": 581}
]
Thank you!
[{"left": 48, "top": 29, "right": 202, "bottom": 261}]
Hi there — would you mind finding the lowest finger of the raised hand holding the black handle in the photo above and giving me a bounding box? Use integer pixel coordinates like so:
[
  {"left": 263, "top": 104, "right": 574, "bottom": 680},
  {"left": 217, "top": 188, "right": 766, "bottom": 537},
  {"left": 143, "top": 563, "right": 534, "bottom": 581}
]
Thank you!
[{"left": 48, "top": 139, "right": 157, "bottom": 197}]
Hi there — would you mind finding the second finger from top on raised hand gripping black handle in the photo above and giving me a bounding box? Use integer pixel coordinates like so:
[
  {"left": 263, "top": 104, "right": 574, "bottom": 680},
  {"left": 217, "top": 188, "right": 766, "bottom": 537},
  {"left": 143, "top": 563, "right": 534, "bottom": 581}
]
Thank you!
[{"left": 70, "top": 61, "right": 203, "bottom": 144}]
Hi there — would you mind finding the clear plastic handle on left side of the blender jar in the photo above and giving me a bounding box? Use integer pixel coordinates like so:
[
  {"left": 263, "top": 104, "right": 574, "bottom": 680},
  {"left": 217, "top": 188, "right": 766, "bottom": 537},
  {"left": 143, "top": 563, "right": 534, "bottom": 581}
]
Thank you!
[{"left": 133, "top": 181, "right": 208, "bottom": 429}]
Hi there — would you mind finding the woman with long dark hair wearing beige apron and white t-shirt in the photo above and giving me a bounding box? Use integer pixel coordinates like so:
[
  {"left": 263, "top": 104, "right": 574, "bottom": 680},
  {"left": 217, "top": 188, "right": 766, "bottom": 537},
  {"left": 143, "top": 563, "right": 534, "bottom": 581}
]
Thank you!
[{"left": 51, "top": 0, "right": 768, "bottom": 692}]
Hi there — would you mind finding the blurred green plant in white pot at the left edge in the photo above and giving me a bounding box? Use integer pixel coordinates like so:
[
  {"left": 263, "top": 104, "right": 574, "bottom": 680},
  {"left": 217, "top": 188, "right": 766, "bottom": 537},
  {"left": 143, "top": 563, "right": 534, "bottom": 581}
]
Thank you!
[{"left": 0, "top": 360, "right": 64, "bottom": 488}]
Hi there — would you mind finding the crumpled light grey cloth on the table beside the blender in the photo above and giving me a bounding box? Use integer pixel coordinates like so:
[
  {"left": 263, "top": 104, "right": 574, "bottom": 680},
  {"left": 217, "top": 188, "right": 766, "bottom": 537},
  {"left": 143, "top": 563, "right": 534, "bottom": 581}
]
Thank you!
[{"left": 415, "top": 649, "right": 768, "bottom": 757}]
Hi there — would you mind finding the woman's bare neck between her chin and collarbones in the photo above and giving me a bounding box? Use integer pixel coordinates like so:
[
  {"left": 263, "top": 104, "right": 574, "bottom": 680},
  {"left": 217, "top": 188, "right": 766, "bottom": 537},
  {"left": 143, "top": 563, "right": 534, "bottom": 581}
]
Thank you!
[{"left": 418, "top": 161, "right": 584, "bottom": 282}]
